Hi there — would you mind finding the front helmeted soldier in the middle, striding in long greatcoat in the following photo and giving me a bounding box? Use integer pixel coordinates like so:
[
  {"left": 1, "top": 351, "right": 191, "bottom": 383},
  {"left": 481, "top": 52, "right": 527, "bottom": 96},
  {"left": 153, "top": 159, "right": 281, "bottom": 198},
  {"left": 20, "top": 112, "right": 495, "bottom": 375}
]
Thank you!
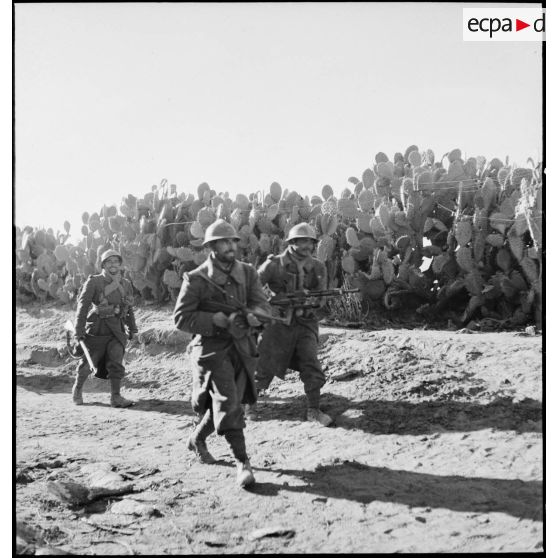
[{"left": 174, "top": 219, "right": 271, "bottom": 487}]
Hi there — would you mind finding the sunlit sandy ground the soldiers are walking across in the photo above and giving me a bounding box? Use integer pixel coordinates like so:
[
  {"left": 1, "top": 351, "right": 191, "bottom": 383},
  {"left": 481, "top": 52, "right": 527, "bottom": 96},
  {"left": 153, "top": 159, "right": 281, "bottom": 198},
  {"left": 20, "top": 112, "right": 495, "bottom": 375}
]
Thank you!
[{"left": 16, "top": 306, "right": 543, "bottom": 554}]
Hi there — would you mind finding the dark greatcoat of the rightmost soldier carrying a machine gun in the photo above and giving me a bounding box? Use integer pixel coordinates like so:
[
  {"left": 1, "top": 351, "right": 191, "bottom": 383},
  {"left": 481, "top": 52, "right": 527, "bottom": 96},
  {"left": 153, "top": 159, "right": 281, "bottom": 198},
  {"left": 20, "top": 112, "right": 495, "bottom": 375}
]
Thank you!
[{"left": 256, "top": 248, "right": 327, "bottom": 392}]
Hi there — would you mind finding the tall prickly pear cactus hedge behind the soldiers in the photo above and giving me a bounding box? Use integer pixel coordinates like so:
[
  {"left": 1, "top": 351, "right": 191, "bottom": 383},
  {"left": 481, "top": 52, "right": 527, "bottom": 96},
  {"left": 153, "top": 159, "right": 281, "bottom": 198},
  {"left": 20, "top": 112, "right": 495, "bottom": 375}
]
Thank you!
[{"left": 15, "top": 149, "right": 543, "bottom": 327}]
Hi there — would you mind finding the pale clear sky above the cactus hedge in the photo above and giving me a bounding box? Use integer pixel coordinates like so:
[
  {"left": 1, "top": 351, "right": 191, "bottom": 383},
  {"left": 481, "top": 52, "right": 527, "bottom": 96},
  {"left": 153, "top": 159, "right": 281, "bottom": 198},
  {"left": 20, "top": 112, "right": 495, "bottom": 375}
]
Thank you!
[{"left": 15, "top": 2, "right": 542, "bottom": 236}]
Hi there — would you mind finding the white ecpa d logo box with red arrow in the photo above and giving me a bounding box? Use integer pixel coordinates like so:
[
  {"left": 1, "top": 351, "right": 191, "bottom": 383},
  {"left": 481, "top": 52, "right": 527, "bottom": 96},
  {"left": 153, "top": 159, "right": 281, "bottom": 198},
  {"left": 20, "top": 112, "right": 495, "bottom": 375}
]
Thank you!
[{"left": 463, "top": 8, "right": 546, "bottom": 41}]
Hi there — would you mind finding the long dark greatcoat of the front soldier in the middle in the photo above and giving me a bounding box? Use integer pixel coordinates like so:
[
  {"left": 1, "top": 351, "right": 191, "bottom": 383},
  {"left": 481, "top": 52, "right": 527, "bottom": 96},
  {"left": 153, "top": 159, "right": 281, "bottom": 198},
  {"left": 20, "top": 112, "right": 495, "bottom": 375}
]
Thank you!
[{"left": 174, "top": 256, "right": 271, "bottom": 434}]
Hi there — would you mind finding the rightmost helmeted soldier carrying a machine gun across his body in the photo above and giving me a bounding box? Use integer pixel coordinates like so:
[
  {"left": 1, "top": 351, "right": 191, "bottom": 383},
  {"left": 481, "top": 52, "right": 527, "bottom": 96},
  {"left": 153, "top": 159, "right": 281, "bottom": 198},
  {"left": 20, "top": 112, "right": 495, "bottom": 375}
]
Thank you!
[{"left": 252, "top": 223, "right": 333, "bottom": 426}]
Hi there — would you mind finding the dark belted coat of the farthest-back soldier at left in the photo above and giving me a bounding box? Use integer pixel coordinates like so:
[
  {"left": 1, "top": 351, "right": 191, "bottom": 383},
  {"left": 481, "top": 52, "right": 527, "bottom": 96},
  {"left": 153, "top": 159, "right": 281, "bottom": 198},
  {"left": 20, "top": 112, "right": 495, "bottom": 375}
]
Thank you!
[{"left": 76, "top": 274, "right": 138, "bottom": 379}]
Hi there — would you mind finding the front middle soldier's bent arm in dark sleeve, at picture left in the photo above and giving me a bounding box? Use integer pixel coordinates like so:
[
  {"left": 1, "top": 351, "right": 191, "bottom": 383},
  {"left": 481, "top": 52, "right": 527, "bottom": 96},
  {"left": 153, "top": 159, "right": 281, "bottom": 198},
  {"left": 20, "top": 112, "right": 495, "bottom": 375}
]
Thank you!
[{"left": 173, "top": 273, "right": 220, "bottom": 337}]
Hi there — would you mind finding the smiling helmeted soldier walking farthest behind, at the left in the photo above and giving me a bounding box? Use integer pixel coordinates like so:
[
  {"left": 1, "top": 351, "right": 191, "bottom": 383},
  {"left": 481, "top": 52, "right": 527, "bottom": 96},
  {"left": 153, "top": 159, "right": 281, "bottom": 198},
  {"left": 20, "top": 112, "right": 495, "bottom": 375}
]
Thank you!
[{"left": 72, "top": 250, "right": 138, "bottom": 407}]
